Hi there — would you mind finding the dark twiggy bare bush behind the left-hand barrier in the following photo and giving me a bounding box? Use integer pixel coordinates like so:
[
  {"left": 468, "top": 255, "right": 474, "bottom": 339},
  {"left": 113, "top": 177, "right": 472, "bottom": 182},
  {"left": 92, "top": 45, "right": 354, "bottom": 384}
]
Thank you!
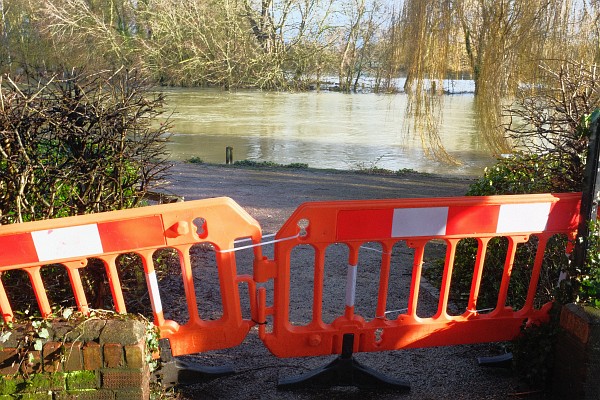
[{"left": 0, "top": 69, "right": 169, "bottom": 224}]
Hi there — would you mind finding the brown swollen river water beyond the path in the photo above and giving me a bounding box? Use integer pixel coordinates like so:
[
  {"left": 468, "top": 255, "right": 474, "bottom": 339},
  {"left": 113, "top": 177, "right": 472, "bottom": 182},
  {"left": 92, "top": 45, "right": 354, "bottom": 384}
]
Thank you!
[{"left": 157, "top": 88, "right": 494, "bottom": 175}]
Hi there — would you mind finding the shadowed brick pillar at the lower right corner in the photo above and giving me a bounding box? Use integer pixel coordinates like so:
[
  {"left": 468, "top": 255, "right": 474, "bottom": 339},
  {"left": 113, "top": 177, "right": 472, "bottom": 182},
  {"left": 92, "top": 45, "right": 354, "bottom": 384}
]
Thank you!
[{"left": 552, "top": 304, "right": 600, "bottom": 400}]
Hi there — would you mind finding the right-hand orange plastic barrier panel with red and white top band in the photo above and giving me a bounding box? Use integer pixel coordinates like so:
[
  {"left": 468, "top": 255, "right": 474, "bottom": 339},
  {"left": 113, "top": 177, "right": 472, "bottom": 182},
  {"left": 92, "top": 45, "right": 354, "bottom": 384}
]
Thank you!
[{"left": 255, "top": 193, "right": 581, "bottom": 357}]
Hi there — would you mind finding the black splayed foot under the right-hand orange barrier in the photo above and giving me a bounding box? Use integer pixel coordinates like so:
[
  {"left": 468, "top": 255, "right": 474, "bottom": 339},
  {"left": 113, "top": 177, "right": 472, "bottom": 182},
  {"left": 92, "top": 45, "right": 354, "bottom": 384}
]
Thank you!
[{"left": 277, "top": 334, "right": 410, "bottom": 392}]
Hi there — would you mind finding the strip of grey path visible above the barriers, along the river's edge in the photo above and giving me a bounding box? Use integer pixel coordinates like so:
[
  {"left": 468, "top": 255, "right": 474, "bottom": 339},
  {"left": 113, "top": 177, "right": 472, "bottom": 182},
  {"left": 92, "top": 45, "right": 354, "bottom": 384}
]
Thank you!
[{"left": 166, "top": 162, "right": 474, "bottom": 232}]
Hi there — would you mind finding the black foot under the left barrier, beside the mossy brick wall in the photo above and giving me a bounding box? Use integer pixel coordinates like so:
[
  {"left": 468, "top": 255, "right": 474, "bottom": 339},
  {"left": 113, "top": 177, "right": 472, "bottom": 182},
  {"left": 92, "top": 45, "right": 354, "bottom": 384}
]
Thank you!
[{"left": 156, "top": 339, "right": 235, "bottom": 387}]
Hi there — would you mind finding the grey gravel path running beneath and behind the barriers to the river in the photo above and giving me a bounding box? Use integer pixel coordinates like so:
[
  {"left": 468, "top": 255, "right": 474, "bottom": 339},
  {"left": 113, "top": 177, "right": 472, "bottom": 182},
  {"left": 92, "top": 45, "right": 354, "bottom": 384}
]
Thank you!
[{"left": 158, "top": 164, "right": 540, "bottom": 399}]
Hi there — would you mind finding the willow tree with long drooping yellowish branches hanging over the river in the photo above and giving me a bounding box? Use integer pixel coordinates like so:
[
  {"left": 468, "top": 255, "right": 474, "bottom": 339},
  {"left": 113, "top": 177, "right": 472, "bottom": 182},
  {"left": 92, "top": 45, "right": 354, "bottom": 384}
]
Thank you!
[{"left": 395, "top": 0, "right": 600, "bottom": 160}]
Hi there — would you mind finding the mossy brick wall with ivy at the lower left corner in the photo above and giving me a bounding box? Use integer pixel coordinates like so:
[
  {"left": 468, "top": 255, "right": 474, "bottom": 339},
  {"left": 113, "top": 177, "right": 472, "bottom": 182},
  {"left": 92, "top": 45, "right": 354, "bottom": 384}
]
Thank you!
[{"left": 0, "top": 321, "right": 150, "bottom": 400}]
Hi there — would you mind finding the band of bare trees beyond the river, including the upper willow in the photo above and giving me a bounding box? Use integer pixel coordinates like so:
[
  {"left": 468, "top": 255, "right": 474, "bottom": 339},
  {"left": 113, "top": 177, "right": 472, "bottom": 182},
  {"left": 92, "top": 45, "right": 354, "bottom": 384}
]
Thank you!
[{"left": 0, "top": 0, "right": 599, "bottom": 91}]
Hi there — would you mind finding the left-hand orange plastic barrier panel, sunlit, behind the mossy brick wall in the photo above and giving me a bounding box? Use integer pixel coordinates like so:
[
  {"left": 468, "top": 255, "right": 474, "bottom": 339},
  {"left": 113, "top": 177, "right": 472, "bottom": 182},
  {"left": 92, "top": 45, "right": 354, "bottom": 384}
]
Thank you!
[{"left": 0, "top": 198, "right": 262, "bottom": 355}]
